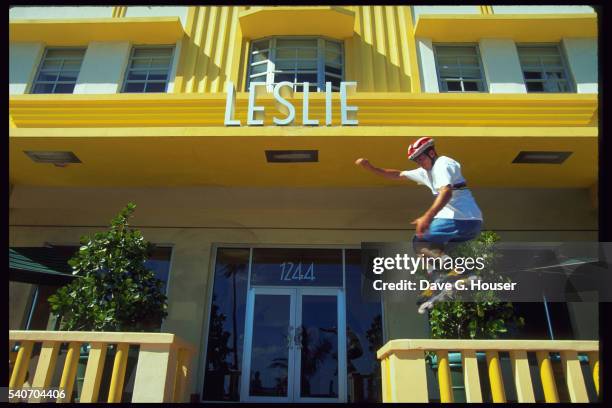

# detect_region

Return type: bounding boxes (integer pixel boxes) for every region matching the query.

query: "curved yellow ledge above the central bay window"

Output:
[238,6,355,39]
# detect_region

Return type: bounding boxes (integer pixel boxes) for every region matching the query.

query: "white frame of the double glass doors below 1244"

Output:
[240,286,347,403]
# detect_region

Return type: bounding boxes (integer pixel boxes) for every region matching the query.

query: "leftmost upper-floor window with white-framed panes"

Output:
[32,48,85,94]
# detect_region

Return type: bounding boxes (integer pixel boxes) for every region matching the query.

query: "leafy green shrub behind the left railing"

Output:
[49,203,167,331]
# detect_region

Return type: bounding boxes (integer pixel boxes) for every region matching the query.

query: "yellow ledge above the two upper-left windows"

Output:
[9,17,184,46]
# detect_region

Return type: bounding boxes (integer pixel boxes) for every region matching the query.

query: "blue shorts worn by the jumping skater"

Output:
[412,218,482,252]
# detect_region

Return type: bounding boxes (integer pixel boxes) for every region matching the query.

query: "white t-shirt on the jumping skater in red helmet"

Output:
[400,156,482,221]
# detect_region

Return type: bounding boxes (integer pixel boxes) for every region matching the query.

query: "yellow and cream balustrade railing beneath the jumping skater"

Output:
[377,339,599,402]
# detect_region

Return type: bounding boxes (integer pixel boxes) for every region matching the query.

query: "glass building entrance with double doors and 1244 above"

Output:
[202,247,383,403]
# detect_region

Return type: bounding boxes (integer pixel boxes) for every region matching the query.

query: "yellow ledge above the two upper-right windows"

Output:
[414,13,597,42]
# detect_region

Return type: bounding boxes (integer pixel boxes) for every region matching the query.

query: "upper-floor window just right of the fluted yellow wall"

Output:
[434,45,486,92]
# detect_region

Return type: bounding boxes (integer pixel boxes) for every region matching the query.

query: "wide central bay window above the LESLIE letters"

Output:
[249,37,344,92]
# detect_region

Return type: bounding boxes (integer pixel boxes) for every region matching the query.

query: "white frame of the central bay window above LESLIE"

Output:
[246,36,346,92]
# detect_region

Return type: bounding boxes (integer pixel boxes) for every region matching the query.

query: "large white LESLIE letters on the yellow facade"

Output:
[224,81,359,126]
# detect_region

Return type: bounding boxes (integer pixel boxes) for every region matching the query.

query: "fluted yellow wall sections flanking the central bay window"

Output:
[174,6,418,93]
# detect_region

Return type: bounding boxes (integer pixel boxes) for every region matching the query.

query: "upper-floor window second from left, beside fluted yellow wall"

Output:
[123,46,174,92]
